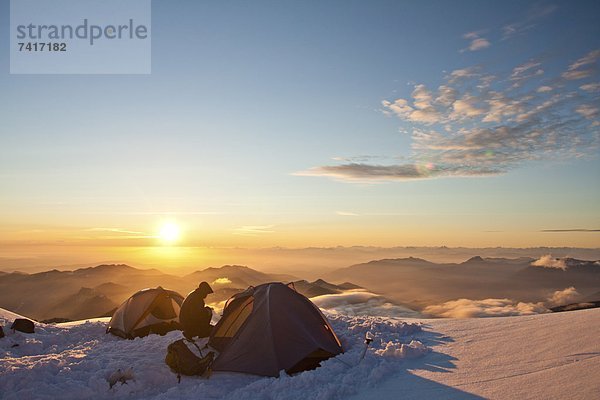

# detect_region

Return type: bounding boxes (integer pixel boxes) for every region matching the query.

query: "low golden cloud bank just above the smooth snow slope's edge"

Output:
[423,299,548,318]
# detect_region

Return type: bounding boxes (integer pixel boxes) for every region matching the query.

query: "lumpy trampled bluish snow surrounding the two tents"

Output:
[0,315,428,400]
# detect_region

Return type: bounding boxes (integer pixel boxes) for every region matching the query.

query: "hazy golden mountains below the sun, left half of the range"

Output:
[0,264,297,320]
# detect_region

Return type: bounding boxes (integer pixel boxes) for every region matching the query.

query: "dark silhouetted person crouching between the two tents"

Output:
[179,282,213,340]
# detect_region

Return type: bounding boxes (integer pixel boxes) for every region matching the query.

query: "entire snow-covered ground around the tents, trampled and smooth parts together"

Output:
[0,309,600,400]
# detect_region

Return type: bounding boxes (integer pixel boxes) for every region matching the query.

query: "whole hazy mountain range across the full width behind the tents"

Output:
[0,256,600,320]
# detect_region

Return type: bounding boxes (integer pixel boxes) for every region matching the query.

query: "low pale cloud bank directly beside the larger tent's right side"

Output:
[310,290,421,318]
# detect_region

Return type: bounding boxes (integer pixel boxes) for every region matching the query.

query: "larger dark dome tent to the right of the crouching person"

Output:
[209,283,343,377]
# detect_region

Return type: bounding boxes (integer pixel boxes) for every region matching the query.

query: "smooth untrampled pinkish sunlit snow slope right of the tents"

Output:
[356,309,600,400]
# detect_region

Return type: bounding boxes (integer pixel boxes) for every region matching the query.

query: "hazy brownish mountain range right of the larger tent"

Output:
[323,256,600,309]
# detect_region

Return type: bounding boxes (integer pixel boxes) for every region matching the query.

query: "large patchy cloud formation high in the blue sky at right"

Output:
[295,48,600,182]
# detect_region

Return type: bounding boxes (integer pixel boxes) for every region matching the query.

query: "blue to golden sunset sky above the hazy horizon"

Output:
[0,0,600,264]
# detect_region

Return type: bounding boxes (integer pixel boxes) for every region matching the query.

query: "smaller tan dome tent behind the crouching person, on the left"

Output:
[106,286,183,339]
